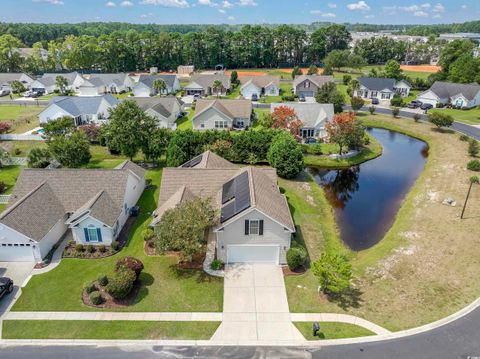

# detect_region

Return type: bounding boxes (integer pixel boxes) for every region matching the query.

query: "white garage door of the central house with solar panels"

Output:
[227,246,280,264]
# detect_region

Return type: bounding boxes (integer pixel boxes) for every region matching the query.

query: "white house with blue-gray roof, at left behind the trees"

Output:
[38,94,118,126]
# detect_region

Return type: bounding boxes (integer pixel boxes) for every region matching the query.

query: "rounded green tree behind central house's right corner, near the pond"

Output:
[267,132,304,178]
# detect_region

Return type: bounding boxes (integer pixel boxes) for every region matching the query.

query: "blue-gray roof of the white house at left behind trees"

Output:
[50,94,118,117]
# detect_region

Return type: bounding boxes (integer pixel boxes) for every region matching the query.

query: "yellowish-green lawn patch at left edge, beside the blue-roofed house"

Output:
[0,105,45,133]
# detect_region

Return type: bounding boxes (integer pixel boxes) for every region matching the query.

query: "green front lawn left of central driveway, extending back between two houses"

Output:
[12,170,223,312]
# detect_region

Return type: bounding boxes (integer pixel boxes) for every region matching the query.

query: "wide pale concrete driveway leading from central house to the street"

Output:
[212,264,304,342]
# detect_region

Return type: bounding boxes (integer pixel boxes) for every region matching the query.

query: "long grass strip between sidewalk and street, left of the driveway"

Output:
[2,320,220,340]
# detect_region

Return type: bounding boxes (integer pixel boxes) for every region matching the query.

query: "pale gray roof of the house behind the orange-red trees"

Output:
[270,102,334,128]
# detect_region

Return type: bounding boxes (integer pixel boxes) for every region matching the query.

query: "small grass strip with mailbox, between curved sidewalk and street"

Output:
[293,322,375,340]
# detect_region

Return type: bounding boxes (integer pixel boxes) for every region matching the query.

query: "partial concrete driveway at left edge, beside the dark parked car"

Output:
[0,262,35,318]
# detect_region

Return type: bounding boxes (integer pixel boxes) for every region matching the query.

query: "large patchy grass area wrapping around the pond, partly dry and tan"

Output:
[281,115,480,331]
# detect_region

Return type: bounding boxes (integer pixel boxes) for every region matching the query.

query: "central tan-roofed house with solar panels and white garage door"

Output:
[151,151,295,264]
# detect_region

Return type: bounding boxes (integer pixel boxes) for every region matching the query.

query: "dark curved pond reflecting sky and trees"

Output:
[308,128,428,251]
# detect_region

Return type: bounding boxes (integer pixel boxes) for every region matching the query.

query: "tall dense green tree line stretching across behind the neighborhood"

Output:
[0,25,351,73]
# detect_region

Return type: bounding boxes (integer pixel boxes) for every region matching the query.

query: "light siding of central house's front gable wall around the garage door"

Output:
[217,209,291,264]
